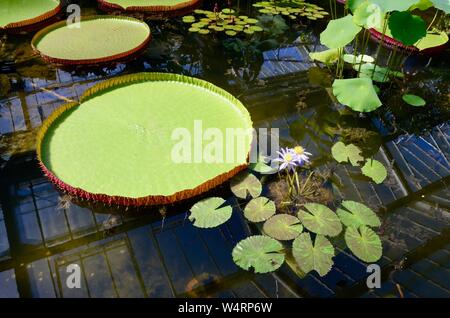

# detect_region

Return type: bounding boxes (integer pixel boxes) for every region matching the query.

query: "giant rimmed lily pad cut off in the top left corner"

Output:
[0,0,61,30]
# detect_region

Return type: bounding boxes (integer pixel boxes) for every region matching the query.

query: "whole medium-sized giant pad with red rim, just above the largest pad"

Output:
[32,16,151,65]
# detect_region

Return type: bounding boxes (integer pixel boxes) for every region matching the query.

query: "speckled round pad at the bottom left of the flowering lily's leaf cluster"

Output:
[232,235,284,274]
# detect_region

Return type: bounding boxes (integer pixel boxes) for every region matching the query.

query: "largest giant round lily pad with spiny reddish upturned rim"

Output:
[37,73,253,206]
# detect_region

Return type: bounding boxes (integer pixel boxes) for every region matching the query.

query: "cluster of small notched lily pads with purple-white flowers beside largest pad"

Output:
[189,144,385,276]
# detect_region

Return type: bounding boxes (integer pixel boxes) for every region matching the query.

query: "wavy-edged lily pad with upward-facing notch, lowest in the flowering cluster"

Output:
[292,233,334,276]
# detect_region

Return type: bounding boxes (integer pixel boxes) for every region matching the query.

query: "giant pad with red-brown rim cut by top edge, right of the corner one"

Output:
[97,0,201,16]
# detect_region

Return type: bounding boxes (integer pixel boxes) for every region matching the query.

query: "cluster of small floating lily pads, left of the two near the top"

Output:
[183,8,263,36]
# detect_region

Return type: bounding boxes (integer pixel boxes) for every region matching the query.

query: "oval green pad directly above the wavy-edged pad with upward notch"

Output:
[297,203,342,236]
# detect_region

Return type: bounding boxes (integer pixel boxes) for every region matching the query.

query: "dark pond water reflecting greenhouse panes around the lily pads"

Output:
[0,1,450,297]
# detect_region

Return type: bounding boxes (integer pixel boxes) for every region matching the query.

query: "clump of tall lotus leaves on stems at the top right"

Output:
[312,0,450,112]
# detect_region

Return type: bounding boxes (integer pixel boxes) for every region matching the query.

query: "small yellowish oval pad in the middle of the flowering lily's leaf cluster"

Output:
[263,214,303,241]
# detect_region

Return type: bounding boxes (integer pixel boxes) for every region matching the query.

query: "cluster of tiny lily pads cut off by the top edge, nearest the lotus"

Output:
[253,0,329,20]
